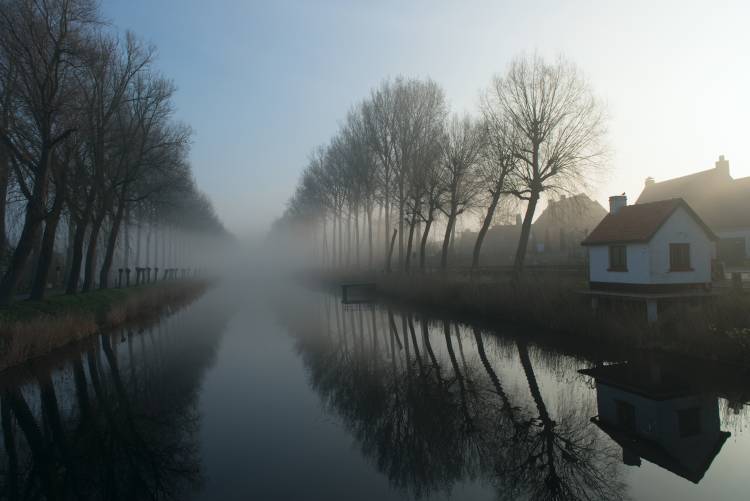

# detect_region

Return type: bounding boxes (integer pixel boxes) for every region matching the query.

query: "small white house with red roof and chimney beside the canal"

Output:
[582,195,717,293]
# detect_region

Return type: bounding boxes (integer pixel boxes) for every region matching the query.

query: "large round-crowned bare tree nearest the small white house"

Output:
[488,54,604,281]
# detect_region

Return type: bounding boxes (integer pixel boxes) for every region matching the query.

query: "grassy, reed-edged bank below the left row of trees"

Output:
[0,280,209,371]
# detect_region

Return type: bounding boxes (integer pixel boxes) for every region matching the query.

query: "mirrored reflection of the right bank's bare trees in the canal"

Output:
[290,298,625,500]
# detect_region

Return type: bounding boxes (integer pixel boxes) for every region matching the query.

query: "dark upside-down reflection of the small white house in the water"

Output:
[581,361,730,484]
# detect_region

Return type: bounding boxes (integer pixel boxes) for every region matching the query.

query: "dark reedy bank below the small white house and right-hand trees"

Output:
[305,272,750,367]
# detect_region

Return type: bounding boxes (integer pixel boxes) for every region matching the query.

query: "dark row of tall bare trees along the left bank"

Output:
[0,0,224,304]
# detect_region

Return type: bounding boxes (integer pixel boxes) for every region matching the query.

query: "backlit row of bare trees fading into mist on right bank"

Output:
[274,54,605,277]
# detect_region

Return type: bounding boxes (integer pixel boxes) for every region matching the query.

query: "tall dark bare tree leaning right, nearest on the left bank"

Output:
[0,0,97,304]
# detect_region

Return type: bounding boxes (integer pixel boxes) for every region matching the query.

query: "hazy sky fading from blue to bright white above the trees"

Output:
[103,0,750,234]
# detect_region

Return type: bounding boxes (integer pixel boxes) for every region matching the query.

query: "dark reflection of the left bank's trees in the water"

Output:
[0,296,225,500]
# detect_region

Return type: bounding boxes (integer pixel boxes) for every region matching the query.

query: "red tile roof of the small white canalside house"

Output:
[581,198,716,245]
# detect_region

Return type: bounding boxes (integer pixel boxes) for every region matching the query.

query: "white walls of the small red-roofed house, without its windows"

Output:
[589,207,715,284]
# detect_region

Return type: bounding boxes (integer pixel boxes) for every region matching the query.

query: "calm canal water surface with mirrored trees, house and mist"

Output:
[0,287,750,501]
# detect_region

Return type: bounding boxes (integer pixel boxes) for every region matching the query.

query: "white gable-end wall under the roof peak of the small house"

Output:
[649,207,715,284]
